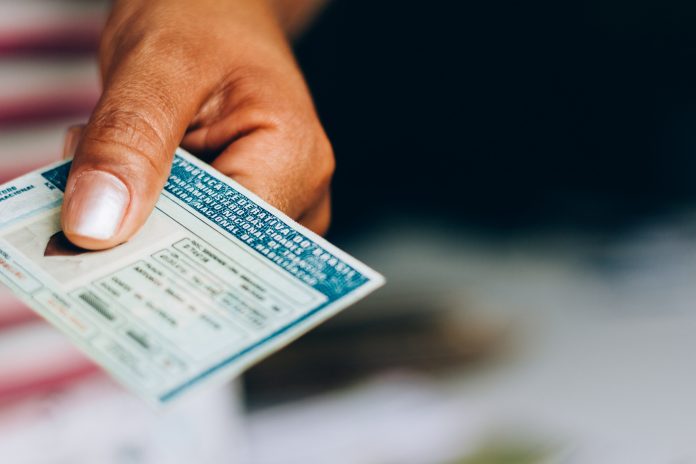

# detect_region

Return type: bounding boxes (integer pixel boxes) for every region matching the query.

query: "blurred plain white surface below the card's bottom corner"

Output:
[0,377,248,464]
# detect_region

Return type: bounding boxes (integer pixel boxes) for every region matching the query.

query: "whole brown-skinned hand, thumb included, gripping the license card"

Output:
[62,0,334,249]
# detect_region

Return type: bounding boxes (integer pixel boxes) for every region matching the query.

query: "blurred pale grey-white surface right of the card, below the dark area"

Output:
[251,218,696,464]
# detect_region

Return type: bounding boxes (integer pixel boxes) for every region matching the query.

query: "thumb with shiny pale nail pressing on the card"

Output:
[61,52,200,250]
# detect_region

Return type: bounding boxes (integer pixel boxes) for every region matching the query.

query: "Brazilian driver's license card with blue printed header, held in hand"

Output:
[0,150,384,405]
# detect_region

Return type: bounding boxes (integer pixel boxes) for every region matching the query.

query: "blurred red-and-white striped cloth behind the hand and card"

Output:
[0,0,106,401]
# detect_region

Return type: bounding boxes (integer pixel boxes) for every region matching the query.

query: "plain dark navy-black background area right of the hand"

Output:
[296,0,696,239]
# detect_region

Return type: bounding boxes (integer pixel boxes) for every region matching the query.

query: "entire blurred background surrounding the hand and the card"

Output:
[0,0,696,464]
